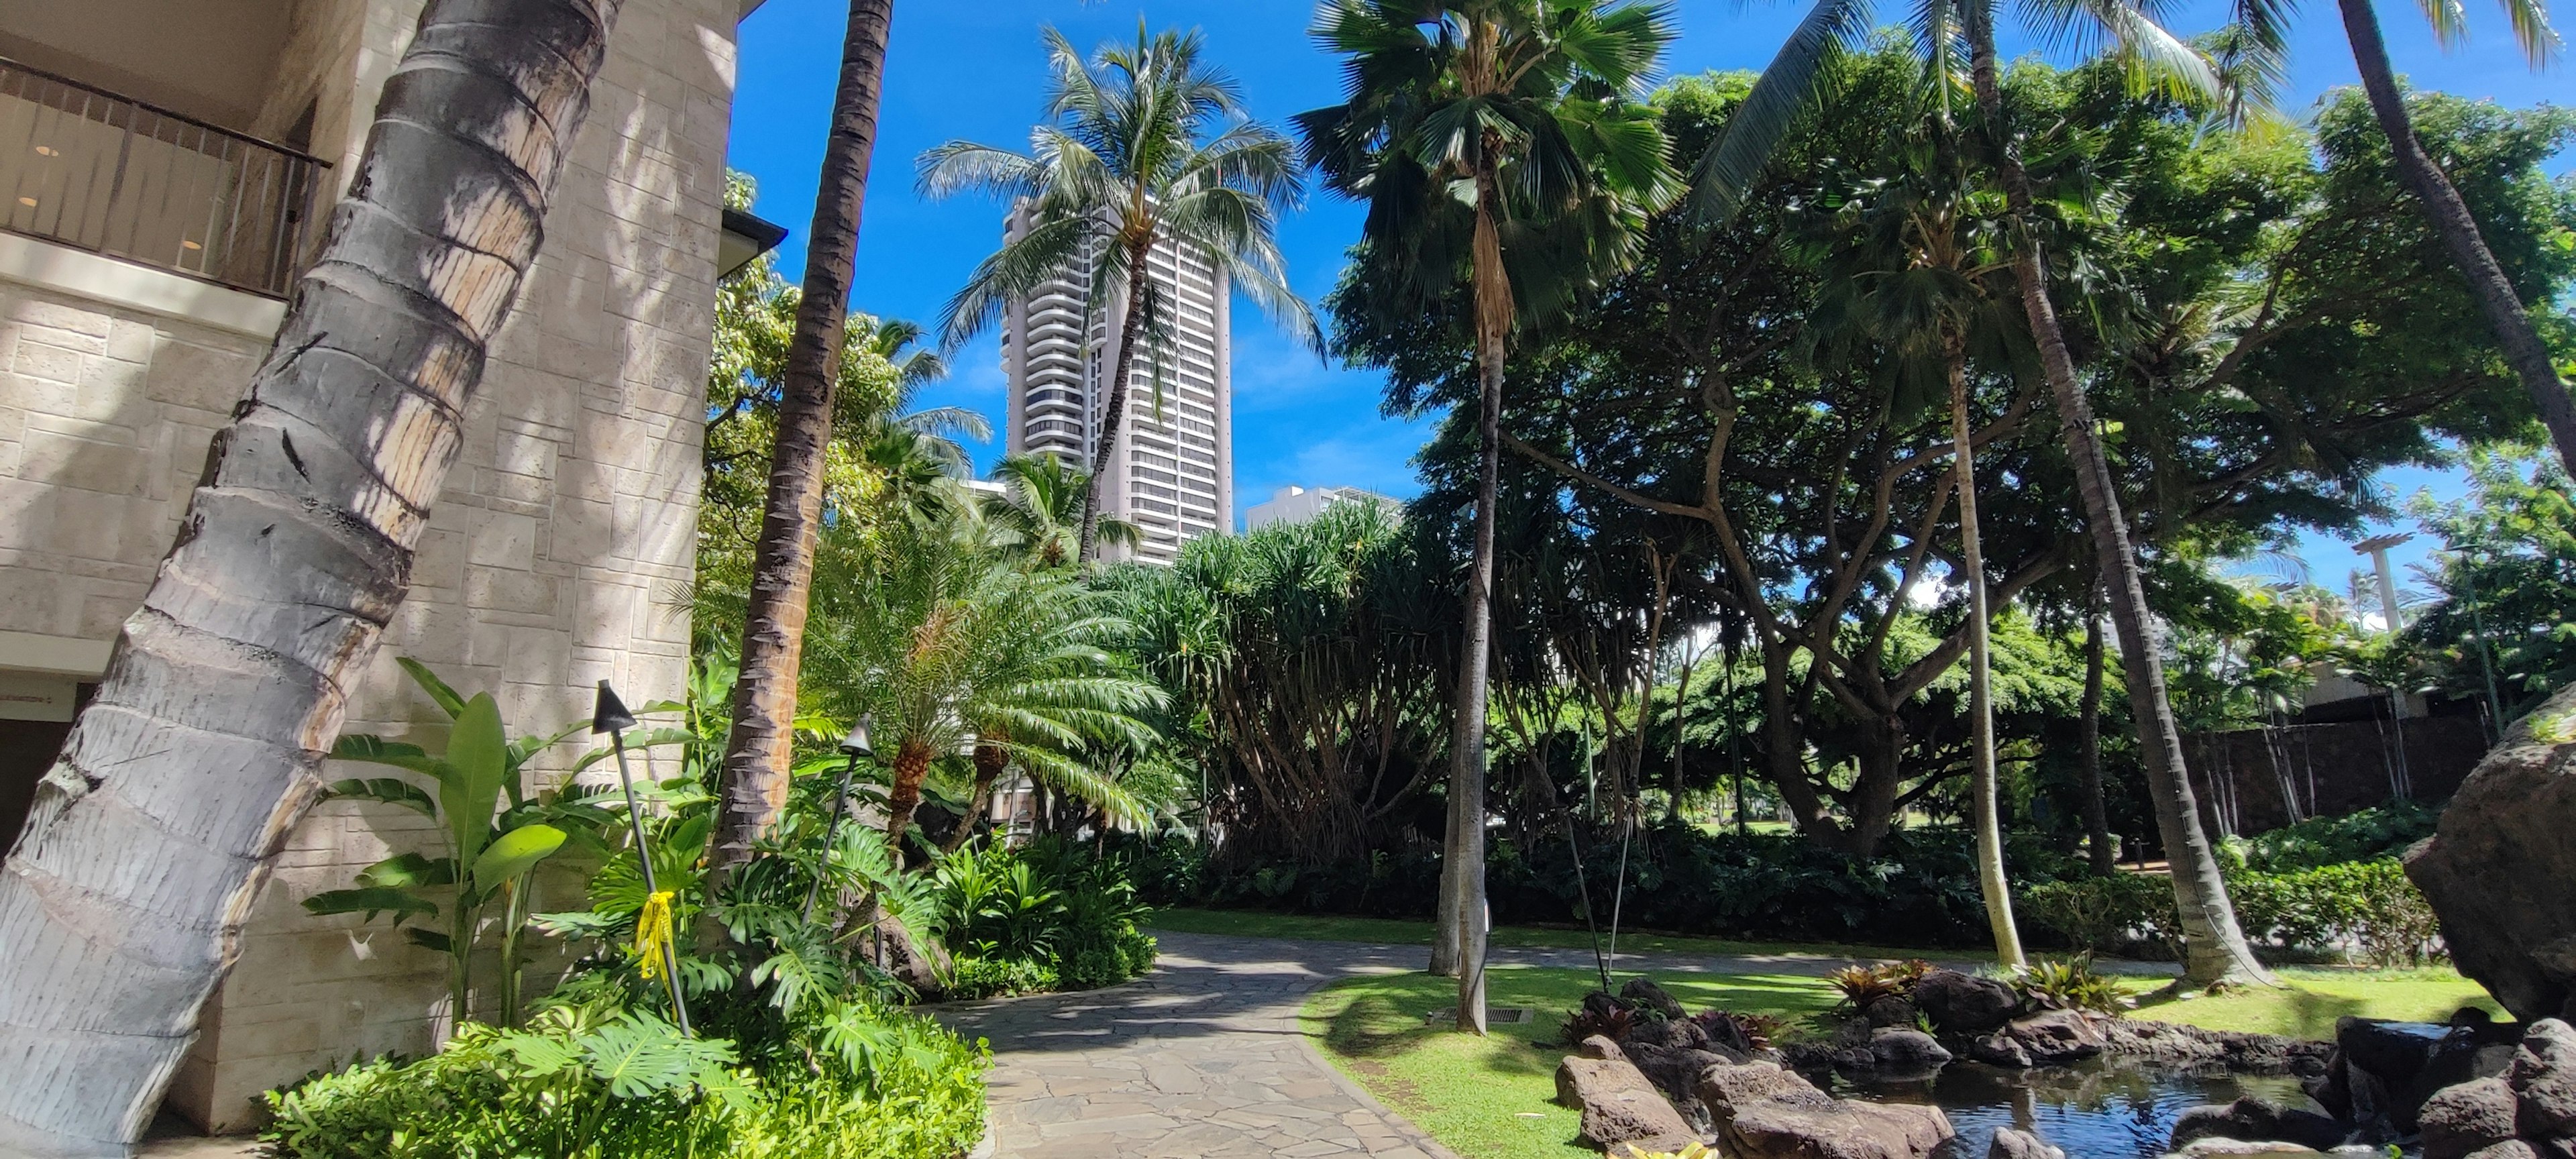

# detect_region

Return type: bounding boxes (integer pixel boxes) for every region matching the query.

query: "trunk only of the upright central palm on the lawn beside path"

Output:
[1448,140,1512,1036]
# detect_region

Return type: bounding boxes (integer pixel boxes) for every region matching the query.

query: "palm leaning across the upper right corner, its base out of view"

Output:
[2318,0,2576,472]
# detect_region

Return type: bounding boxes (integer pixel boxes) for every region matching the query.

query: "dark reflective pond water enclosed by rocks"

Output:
[1837,1058,2316,1159]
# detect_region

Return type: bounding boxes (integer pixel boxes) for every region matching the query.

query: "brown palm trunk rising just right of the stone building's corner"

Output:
[700,0,894,885]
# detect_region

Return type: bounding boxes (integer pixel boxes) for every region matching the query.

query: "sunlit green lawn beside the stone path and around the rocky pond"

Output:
[1308,963,2496,1159]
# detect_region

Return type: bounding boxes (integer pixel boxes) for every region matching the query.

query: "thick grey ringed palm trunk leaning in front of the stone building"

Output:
[0,0,619,1156]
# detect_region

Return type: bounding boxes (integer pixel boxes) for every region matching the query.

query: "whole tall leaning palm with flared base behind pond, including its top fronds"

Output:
[1695,0,2272,987]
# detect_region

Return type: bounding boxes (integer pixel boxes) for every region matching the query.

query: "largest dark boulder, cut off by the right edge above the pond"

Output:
[2406,685,2576,1022]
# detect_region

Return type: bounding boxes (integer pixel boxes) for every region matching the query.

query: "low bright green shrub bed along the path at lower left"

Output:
[260,1005,989,1159]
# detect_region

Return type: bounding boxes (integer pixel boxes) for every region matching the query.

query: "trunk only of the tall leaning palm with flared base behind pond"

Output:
[1966,0,2272,987]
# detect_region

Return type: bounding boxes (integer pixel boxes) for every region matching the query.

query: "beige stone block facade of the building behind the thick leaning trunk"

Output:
[0,0,745,1131]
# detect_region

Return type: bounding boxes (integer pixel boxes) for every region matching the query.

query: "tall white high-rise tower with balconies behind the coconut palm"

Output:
[1002,211,1234,564]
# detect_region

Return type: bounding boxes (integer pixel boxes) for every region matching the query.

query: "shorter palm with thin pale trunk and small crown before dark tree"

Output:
[1824,117,2027,969]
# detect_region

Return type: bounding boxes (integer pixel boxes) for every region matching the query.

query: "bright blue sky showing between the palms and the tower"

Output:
[729,0,2568,577]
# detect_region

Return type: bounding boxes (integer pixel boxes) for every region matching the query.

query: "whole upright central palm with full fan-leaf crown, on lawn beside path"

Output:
[1296,0,1680,1036]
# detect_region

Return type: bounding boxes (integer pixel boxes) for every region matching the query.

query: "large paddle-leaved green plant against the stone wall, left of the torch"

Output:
[304,659,588,1025]
